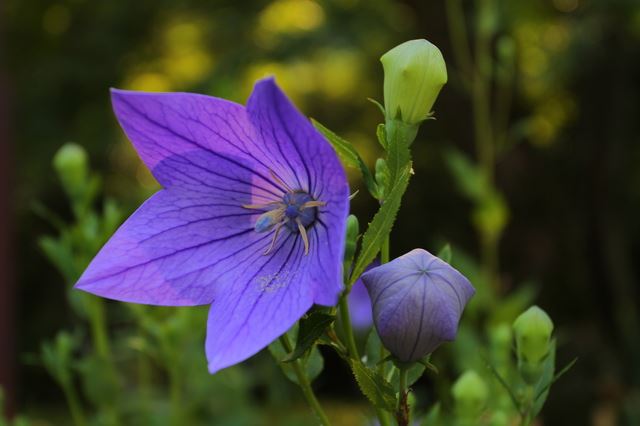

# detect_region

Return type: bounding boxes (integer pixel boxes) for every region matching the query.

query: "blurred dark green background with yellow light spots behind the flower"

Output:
[0,0,640,425]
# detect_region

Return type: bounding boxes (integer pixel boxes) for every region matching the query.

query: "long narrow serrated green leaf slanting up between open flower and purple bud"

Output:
[349,163,411,284]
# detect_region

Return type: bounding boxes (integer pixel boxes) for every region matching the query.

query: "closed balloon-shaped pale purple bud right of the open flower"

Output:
[362,249,475,362]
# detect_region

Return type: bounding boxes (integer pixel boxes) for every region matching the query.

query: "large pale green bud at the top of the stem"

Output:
[380,40,447,125]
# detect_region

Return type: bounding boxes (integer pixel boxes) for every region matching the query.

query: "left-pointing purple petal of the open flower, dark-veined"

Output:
[76,185,270,306]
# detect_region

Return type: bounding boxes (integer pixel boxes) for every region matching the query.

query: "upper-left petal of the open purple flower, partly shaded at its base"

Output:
[111,89,292,202]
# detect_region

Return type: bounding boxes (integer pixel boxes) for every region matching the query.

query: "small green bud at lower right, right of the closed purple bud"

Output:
[513,306,553,384]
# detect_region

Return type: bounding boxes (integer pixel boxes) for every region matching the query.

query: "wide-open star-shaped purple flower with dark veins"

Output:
[76,79,349,373]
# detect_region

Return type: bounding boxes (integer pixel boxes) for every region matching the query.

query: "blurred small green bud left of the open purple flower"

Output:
[53,143,89,197]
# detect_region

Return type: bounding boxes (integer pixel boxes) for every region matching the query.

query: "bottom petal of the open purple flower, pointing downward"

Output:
[206,234,313,373]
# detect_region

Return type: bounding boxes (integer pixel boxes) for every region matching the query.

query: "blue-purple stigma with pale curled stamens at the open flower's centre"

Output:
[243,187,325,254]
